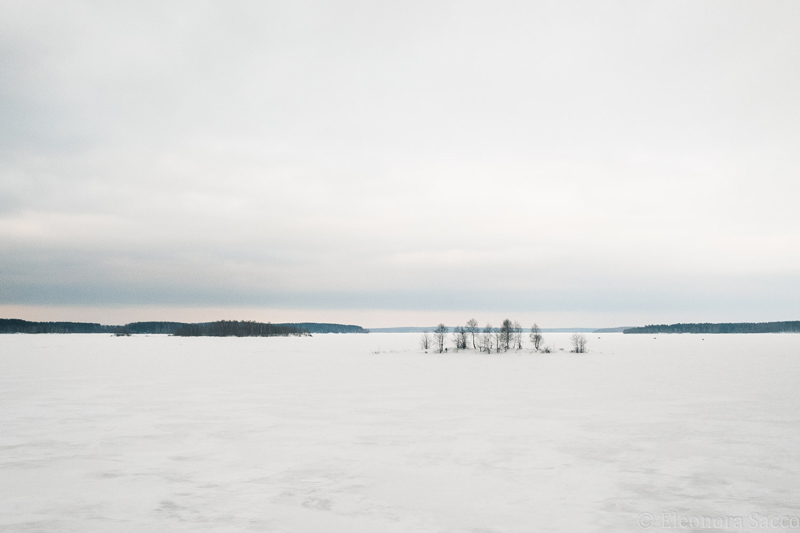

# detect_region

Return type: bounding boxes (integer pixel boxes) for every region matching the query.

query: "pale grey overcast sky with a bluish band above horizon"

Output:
[0,0,800,327]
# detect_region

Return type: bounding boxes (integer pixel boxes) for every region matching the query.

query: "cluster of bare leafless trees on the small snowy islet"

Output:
[420,318,587,353]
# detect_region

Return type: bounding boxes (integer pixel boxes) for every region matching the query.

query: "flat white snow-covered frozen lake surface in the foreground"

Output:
[0,334,800,533]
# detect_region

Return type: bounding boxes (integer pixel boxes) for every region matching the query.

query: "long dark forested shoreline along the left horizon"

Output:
[0,318,369,336]
